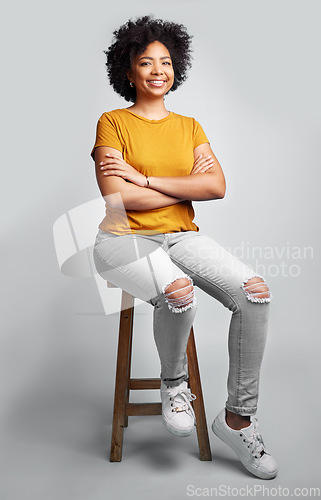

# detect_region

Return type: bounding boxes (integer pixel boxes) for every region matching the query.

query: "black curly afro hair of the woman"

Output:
[104,15,192,102]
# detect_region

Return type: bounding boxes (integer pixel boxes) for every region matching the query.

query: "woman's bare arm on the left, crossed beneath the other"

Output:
[95,146,182,210]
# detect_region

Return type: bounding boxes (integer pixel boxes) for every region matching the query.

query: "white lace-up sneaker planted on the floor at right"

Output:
[212,409,278,479]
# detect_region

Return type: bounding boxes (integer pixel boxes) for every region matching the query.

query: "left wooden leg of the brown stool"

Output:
[110,291,134,462]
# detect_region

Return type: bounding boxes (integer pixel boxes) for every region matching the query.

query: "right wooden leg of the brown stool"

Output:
[187,327,212,460]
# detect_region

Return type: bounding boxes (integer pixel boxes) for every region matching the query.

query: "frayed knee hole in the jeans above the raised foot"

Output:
[163,277,195,312]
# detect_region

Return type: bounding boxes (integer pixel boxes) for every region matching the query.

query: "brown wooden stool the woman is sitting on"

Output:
[107,282,212,462]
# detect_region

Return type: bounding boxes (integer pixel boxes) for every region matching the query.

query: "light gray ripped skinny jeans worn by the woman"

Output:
[94,230,271,415]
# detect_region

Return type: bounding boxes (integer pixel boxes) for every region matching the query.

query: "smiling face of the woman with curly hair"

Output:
[127,41,174,99]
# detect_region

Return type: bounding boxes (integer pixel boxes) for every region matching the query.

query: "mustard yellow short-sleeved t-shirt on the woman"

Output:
[91,108,209,234]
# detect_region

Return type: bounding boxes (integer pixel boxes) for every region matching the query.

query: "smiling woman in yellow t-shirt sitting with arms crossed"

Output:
[92,16,277,479]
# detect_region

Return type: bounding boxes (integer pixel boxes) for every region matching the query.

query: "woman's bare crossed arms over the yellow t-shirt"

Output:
[95,143,225,210]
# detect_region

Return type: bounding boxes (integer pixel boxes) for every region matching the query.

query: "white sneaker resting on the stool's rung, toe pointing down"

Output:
[161,381,196,437]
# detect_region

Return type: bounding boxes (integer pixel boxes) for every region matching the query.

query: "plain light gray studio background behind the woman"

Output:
[0,0,321,500]
